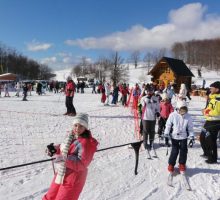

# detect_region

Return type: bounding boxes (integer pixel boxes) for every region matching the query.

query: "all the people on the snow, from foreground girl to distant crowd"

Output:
[0,76,220,200]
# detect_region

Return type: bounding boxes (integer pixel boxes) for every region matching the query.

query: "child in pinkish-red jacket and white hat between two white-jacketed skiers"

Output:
[157,93,174,143]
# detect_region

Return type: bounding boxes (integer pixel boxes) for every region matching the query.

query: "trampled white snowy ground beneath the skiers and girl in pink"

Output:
[0,88,220,200]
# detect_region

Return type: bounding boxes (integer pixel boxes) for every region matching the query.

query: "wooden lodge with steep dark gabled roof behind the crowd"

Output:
[148,57,194,90]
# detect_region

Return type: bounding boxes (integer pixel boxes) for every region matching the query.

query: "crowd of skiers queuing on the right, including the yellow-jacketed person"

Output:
[92,81,220,169]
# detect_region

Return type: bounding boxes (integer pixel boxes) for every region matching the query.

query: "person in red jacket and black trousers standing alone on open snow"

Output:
[64,76,76,116]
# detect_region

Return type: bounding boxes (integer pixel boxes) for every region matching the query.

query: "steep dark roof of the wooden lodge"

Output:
[149,57,194,77]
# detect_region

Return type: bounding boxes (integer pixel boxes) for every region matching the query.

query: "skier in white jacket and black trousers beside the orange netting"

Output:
[141,89,160,150]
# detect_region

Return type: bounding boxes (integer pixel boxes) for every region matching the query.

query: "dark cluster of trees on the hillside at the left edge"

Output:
[0,43,55,80]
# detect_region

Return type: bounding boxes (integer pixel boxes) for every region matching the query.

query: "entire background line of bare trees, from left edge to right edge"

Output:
[0,38,220,84]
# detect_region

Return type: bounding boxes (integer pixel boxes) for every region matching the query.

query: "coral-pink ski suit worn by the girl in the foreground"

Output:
[43,130,98,200]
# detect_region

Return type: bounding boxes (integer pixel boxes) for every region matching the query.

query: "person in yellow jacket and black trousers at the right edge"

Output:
[203,81,220,164]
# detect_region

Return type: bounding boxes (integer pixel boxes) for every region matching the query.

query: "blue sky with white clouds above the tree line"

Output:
[0,0,220,69]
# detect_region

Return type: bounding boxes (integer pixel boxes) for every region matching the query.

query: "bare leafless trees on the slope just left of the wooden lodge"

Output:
[72,48,166,85]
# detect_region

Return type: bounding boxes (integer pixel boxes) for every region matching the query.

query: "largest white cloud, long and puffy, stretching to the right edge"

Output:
[65,3,220,51]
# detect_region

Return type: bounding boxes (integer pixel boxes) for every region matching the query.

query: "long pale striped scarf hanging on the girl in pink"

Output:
[55,133,74,184]
